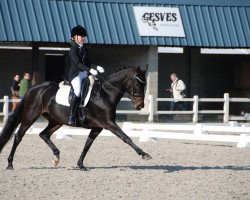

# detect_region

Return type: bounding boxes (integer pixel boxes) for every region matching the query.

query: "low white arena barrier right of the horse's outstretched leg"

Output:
[122,122,250,148]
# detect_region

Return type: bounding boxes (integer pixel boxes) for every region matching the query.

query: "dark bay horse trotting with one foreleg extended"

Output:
[0,67,151,171]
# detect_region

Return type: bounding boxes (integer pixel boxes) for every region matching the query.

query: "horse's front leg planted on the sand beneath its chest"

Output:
[77,128,102,171]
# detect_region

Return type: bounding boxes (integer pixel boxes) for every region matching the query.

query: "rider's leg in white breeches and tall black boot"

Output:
[68,72,87,125]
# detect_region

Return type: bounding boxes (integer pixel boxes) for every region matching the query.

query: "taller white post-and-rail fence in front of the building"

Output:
[0,93,250,123]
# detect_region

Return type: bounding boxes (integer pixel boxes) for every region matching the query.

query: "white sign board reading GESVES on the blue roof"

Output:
[133,6,185,37]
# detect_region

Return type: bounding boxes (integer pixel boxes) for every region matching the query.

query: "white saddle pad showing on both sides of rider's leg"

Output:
[56,75,95,107]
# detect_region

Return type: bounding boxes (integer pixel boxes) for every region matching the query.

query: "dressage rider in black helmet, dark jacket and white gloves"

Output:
[68,25,104,125]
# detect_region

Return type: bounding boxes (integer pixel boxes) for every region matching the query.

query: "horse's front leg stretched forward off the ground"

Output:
[105,122,152,160]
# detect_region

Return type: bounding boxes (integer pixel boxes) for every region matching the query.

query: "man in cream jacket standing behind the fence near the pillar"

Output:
[166,73,186,111]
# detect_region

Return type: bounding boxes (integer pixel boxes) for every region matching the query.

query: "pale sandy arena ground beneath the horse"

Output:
[0,135,250,200]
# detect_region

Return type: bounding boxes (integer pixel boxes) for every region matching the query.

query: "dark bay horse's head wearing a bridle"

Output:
[126,66,148,110]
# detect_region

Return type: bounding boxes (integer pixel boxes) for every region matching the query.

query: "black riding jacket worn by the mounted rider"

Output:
[68,42,91,82]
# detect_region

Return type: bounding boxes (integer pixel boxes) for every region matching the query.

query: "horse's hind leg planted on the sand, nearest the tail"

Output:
[7,116,39,169]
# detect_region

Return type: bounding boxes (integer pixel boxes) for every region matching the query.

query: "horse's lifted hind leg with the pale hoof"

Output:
[39,121,62,166]
